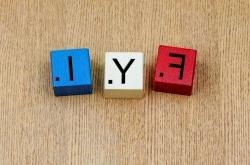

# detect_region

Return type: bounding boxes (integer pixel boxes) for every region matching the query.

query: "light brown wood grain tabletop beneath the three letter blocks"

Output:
[0,0,250,165]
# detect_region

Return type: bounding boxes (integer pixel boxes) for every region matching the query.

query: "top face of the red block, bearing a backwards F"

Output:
[154,46,197,86]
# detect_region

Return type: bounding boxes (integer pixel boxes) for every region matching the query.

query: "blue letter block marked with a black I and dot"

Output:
[50,49,92,96]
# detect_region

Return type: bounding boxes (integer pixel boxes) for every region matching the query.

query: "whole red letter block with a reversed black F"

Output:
[154,46,197,96]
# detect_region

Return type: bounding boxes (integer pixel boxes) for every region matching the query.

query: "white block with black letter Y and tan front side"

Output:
[104,52,144,98]
